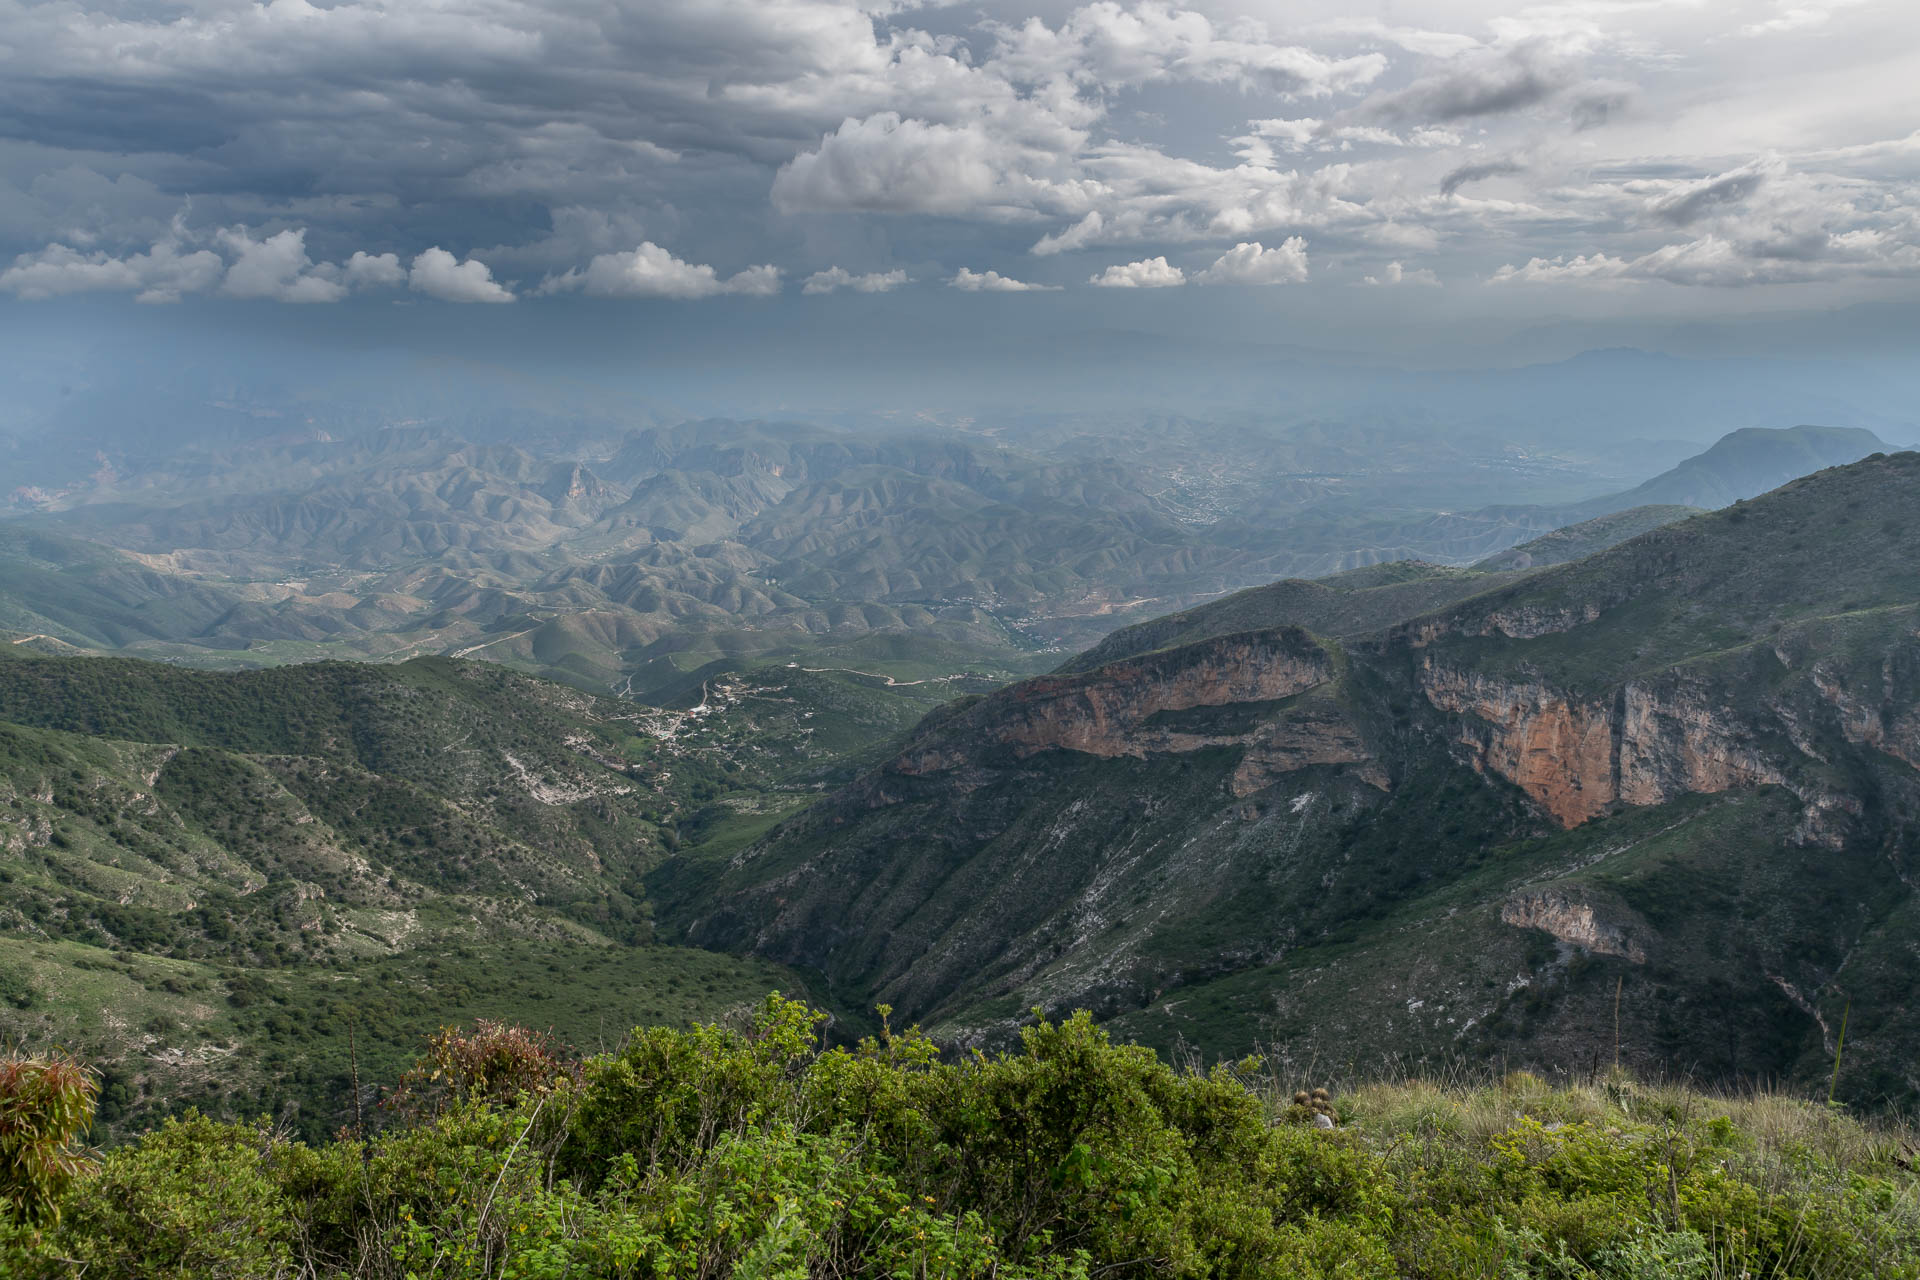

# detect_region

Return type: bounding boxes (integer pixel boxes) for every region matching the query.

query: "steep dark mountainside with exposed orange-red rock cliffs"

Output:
[683,455,1920,1096]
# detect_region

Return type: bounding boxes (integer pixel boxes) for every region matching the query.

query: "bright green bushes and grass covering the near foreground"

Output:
[0,996,1920,1280]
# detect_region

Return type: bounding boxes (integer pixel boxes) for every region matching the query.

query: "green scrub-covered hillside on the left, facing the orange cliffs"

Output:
[0,656,793,1132]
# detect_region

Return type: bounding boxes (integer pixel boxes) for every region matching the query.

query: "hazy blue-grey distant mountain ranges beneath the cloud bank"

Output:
[0,416,1878,710]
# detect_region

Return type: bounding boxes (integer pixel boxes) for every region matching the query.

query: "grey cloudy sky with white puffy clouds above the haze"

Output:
[0,0,1920,360]
